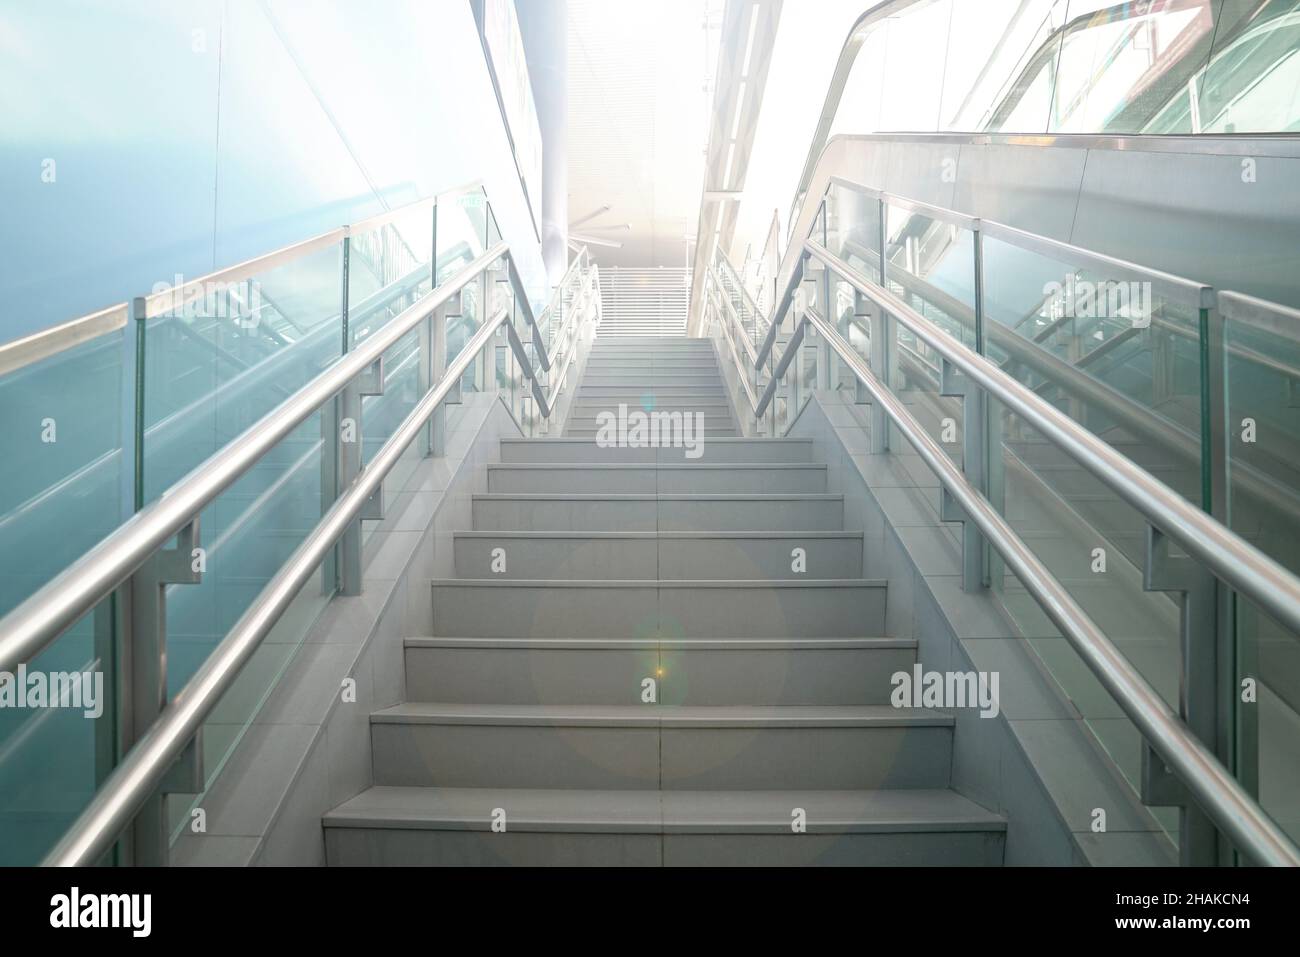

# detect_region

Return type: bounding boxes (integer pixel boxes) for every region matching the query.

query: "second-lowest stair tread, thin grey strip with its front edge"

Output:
[371,701,953,728]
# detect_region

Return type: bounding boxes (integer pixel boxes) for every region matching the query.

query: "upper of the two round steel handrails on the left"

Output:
[0,242,508,671]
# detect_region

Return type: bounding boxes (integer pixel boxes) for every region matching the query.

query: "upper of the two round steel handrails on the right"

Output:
[803,239,1300,632]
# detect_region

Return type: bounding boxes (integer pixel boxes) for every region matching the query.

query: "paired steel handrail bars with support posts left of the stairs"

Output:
[0,231,599,865]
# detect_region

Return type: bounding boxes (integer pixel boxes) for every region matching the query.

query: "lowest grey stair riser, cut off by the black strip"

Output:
[325,827,1005,867]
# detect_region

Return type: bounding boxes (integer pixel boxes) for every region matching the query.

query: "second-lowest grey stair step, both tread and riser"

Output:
[371,702,953,791]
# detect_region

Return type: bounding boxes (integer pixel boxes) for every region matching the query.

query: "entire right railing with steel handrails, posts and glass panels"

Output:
[706,171,1300,865]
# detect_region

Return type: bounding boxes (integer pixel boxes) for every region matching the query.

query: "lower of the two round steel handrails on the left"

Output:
[43,304,508,867]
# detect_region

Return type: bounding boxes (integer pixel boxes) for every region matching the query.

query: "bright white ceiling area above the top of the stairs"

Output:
[568,0,723,267]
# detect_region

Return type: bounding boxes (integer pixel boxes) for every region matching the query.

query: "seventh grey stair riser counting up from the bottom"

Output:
[488,465,827,494]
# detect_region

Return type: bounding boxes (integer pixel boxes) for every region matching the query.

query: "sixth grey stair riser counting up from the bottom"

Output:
[473,498,844,532]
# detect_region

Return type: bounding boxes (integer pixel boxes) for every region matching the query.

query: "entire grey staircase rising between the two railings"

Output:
[324,339,1005,865]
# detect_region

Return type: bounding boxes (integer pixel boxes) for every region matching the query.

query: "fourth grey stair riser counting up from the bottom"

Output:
[433,584,885,638]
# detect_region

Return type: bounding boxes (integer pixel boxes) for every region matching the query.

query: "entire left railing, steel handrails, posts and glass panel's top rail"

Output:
[0,187,599,863]
